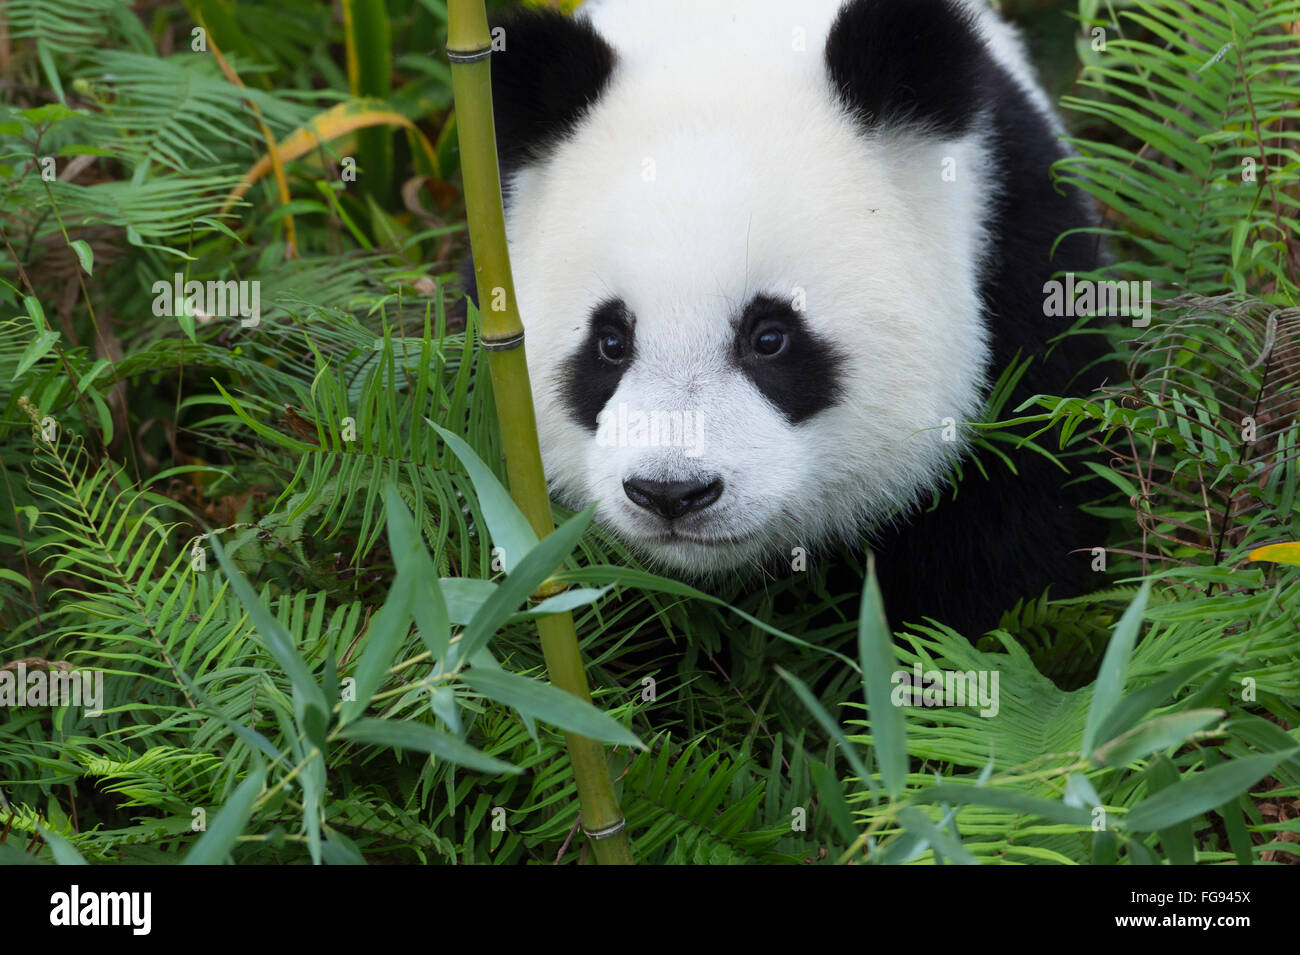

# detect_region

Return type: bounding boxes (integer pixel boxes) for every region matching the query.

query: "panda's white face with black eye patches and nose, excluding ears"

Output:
[488,0,992,576]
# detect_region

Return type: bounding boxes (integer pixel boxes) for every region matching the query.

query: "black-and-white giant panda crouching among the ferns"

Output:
[469,0,1102,634]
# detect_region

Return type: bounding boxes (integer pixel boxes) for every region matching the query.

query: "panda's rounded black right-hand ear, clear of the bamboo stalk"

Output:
[826,0,992,135]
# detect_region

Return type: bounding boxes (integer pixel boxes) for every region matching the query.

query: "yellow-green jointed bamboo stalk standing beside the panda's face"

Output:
[447,0,632,865]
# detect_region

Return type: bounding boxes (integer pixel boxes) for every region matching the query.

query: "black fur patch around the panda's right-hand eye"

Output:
[732,295,842,425]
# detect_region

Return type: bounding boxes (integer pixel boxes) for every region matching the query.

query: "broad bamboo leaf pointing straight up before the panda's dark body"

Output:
[858,557,907,799]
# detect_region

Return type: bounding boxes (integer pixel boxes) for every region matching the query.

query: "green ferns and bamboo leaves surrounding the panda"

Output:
[0,0,1300,864]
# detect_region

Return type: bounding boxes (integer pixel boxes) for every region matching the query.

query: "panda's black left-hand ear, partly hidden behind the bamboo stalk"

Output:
[491,10,615,170]
